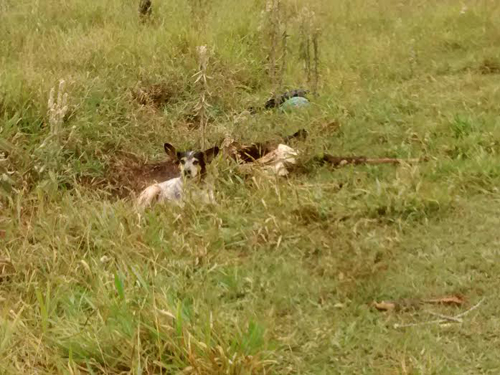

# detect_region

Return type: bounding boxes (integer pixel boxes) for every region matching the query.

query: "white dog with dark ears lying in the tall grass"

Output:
[137,143,219,209]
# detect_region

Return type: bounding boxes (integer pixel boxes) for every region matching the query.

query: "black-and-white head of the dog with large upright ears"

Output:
[163,143,219,178]
